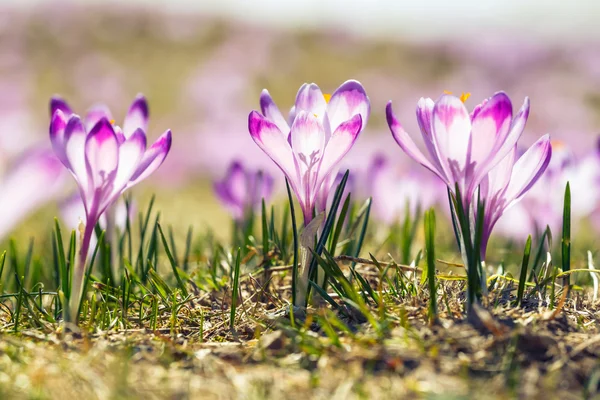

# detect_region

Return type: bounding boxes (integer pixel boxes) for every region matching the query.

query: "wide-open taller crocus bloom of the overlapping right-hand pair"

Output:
[386,92,529,209]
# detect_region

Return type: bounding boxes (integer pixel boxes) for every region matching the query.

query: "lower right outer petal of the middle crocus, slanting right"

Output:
[317,114,362,187]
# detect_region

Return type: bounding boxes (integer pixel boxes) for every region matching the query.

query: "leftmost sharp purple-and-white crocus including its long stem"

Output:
[50,95,171,321]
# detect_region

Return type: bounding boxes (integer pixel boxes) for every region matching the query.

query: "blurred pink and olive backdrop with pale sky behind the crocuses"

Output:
[0,0,600,253]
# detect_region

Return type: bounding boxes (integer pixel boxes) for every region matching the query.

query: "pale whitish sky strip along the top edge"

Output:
[0,0,600,41]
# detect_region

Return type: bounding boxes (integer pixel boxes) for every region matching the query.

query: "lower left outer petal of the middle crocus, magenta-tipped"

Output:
[248,111,300,188]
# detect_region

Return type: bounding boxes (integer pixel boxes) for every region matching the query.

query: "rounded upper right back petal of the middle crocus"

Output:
[327,80,371,132]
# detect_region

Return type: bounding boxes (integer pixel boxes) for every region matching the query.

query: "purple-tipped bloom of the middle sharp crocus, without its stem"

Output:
[248,80,370,225]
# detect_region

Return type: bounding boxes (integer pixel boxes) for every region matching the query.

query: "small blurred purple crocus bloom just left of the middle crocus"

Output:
[213,161,273,223]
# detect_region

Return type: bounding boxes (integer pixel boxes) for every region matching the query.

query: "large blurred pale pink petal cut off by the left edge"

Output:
[0,149,65,238]
